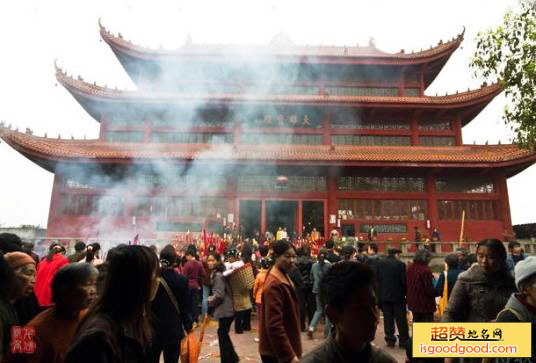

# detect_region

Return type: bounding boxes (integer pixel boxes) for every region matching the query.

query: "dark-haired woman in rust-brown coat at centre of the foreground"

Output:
[259,241,302,363]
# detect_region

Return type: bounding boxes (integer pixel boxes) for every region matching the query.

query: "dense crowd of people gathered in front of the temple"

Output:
[0,234,536,363]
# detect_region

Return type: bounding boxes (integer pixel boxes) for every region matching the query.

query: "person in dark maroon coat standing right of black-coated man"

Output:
[407,249,436,322]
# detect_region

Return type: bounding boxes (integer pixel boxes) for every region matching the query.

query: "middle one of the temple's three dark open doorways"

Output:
[266,200,298,238]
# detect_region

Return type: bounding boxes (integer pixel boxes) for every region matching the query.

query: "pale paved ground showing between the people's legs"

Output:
[182,318,406,363]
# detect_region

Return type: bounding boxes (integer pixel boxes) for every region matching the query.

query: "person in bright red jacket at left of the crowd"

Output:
[34,242,69,306]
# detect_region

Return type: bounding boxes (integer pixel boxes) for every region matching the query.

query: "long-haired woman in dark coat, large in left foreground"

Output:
[65,245,160,363]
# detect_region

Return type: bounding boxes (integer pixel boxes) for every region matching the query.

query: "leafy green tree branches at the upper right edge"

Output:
[471,0,536,150]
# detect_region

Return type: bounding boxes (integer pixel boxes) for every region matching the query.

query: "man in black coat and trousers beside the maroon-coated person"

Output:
[378,248,409,347]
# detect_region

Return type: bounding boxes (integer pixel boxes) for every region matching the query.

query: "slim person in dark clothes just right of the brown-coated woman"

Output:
[296,246,316,332]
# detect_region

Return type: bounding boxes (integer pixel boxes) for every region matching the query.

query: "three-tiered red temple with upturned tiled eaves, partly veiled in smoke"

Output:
[0,25,536,245]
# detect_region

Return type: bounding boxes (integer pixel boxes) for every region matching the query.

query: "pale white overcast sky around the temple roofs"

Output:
[0,0,536,226]
